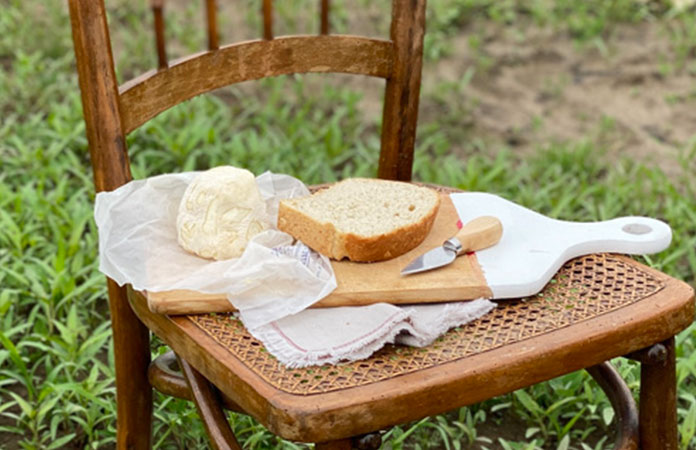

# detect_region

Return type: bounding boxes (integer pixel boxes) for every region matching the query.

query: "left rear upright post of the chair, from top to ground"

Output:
[68,0,152,449]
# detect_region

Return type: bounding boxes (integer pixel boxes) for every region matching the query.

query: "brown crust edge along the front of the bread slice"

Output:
[278,182,440,262]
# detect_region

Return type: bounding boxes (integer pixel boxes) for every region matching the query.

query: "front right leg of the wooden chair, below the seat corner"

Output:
[640,338,679,450]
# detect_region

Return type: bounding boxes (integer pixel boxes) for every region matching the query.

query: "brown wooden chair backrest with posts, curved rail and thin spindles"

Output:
[69,0,426,191]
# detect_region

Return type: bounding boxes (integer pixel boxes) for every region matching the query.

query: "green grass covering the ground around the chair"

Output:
[0,0,696,449]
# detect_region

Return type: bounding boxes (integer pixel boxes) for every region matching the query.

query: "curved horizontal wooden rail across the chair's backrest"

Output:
[119,35,393,133]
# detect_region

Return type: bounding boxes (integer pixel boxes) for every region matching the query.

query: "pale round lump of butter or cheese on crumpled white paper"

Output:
[176,166,270,260]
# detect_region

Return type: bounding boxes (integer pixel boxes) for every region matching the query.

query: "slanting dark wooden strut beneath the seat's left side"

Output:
[177,357,241,450]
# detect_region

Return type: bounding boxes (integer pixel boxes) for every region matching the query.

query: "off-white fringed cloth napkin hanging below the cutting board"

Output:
[250,299,495,368]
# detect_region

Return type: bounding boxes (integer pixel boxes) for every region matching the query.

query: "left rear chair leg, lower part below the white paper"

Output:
[107,279,152,450]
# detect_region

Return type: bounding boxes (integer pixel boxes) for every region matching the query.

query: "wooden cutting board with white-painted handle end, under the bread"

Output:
[148,192,672,314]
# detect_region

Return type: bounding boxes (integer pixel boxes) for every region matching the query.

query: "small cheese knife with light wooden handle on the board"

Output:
[401,216,503,275]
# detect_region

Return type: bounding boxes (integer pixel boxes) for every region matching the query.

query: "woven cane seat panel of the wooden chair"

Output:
[188,254,664,395]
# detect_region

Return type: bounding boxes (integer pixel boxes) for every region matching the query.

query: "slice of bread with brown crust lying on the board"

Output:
[278,178,440,262]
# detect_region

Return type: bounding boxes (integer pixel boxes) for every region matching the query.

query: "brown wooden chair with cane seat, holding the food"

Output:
[69,0,694,449]
